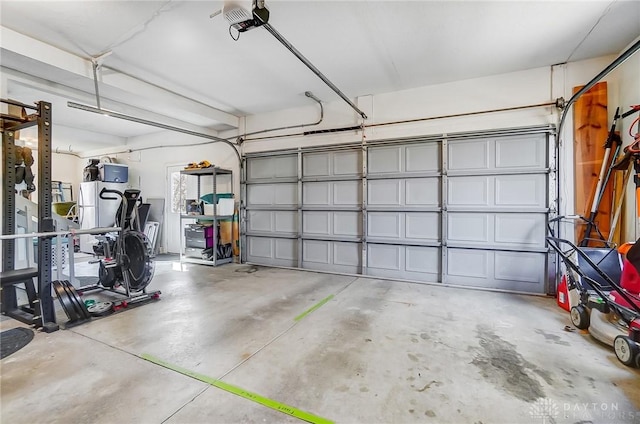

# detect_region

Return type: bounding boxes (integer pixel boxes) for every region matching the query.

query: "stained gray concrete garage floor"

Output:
[0,262,640,424]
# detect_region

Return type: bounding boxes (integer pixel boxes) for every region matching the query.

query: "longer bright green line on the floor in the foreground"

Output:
[140,352,333,424]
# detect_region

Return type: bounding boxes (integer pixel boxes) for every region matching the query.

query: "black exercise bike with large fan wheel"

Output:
[82,188,161,309]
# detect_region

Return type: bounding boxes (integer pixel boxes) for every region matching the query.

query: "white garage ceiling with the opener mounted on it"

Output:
[0,0,640,152]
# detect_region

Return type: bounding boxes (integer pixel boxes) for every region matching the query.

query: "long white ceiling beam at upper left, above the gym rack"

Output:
[0,26,239,128]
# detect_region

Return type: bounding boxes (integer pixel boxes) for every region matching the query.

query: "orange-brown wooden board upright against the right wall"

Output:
[573,82,613,245]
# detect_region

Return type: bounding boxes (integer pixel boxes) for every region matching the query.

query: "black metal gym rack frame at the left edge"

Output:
[0,99,59,332]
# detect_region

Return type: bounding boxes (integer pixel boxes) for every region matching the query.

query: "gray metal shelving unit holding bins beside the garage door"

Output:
[180,166,233,266]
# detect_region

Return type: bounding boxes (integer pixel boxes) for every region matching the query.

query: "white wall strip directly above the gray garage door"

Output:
[234,56,617,157]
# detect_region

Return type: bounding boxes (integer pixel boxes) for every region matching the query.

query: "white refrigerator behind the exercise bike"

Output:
[78,181,127,253]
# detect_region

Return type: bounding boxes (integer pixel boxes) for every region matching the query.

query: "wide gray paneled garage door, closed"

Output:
[242,127,555,293]
